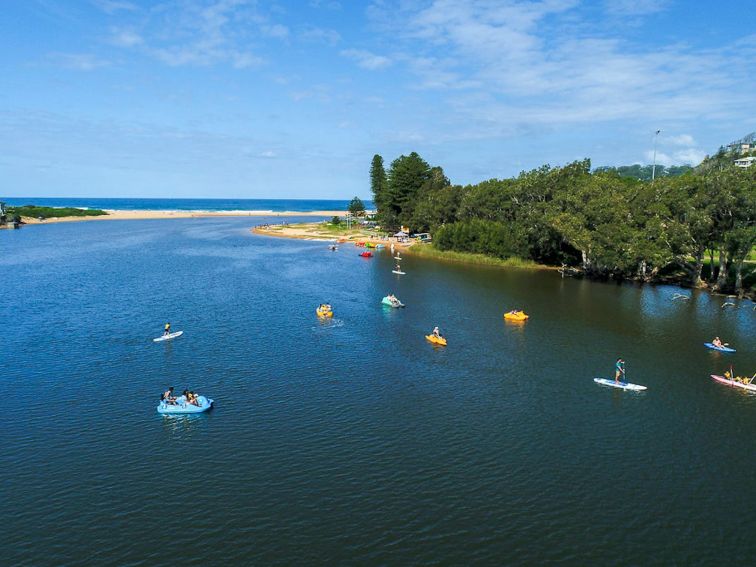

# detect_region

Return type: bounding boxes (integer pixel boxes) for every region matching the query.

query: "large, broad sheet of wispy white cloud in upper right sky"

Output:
[368,0,753,138]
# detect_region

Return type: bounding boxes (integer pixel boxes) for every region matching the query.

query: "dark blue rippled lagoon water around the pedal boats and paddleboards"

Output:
[0,218,756,566]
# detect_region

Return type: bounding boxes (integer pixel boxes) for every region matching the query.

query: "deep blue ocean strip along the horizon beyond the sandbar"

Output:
[0,196,374,213]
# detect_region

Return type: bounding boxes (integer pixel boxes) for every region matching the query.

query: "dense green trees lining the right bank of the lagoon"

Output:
[371,153,756,293]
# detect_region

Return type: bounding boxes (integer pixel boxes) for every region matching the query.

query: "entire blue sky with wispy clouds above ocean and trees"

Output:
[0,0,756,198]
